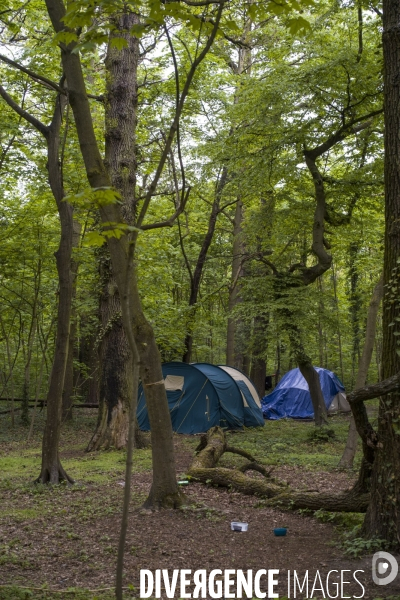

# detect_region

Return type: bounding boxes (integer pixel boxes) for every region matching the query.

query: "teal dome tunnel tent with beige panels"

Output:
[137,362,264,433]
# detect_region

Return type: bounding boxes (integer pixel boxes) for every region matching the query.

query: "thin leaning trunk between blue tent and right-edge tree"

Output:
[338,278,383,469]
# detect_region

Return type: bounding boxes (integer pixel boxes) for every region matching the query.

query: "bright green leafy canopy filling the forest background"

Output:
[0,0,383,434]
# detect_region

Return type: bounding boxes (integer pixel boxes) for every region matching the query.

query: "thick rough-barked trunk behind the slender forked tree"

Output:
[88,13,139,451]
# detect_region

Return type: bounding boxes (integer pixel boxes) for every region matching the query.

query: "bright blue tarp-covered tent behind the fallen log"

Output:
[262,367,350,420]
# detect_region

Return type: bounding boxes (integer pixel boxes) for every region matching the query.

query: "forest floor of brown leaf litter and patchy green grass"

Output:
[0,409,400,600]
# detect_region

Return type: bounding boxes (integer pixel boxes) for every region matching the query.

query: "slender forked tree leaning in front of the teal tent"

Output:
[46,0,228,507]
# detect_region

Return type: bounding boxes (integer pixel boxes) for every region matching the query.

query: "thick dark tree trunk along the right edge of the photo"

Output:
[363,0,400,548]
